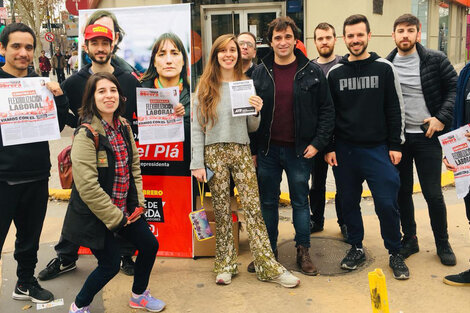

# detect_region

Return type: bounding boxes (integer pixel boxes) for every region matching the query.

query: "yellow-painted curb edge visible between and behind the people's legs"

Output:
[49,171,454,205]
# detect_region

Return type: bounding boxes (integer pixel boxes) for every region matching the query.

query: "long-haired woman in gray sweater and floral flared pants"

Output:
[190,34,300,288]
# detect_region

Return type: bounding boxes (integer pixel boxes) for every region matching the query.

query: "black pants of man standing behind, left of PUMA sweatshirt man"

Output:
[308,153,344,227]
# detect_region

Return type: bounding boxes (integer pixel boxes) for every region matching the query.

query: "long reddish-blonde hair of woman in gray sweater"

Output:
[196,34,245,132]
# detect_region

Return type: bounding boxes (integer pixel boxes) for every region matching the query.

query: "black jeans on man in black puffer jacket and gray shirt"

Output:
[397,133,449,244]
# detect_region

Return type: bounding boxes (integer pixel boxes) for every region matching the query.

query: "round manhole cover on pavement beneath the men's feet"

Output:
[277,236,374,276]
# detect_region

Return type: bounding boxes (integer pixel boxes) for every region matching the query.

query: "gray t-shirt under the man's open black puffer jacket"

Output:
[393,52,431,133]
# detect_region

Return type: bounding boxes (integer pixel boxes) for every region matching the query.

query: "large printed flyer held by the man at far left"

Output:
[0,77,60,146]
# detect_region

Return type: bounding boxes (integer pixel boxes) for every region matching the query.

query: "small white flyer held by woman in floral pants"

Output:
[229,79,256,116]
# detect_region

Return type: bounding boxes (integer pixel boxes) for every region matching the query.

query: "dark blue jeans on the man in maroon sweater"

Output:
[257,144,312,251]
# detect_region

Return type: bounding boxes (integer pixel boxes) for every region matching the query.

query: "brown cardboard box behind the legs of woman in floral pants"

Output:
[193,197,240,257]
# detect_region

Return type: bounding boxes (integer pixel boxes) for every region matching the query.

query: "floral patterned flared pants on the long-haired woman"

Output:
[204,143,286,280]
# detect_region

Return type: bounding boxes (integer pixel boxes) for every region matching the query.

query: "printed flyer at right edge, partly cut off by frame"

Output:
[438,124,470,199]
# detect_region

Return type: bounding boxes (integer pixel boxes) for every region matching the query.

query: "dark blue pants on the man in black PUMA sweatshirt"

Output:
[334,142,401,253]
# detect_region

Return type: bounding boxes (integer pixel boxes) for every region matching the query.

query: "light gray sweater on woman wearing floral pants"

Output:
[190,82,261,170]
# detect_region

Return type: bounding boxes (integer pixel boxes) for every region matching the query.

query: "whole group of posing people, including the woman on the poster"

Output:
[0,7,470,313]
